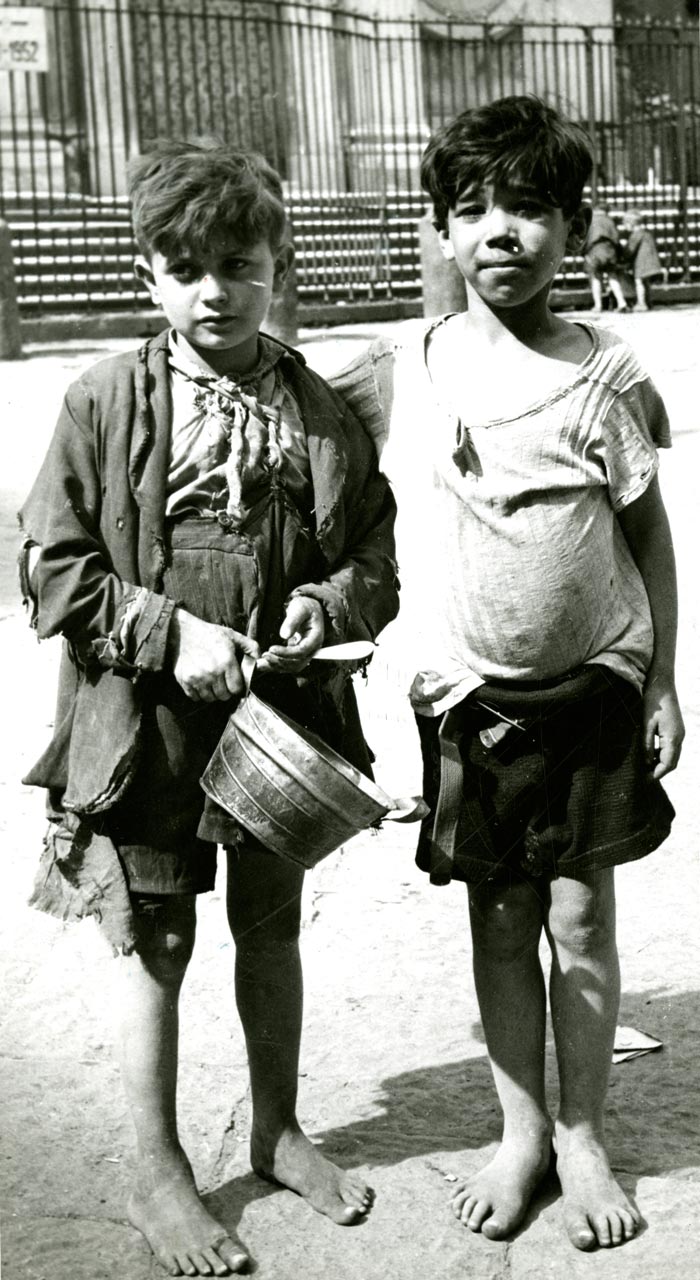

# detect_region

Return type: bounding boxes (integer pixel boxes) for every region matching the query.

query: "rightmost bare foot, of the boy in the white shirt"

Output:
[557,1125,641,1249]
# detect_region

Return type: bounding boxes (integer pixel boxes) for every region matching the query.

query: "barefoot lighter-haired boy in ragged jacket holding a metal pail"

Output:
[22,143,398,1276]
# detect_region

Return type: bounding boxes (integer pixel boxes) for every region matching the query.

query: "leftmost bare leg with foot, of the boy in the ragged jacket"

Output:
[118,897,250,1276]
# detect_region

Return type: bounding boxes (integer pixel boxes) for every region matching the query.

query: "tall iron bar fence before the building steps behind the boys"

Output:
[0,0,700,311]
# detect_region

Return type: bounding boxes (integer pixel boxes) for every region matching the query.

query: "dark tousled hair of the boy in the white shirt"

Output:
[421,95,593,230]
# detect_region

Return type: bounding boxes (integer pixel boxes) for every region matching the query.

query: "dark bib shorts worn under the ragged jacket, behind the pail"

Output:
[102,512,371,893]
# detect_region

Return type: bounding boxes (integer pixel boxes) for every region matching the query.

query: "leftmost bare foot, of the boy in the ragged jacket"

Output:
[128,1156,250,1276]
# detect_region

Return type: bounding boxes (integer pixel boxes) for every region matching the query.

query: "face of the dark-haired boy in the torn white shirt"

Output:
[440,183,587,310]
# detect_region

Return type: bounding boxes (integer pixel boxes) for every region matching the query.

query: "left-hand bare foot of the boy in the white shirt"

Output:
[452,1133,552,1240]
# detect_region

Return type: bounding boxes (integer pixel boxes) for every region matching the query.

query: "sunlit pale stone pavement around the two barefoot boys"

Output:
[0,308,700,1280]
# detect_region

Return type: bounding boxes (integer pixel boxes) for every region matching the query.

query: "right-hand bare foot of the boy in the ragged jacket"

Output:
[251,1129,375,1226]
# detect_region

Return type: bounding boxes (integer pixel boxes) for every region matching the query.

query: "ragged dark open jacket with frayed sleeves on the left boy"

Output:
[20,333,398,936]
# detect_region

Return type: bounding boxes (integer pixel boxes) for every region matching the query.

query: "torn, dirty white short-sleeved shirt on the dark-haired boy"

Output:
[338,316,671,714]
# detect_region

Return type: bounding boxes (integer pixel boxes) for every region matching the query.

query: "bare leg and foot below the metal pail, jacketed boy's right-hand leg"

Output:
[228,850,374,1225]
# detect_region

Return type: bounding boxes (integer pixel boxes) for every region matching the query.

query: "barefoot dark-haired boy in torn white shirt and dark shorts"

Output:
[337,97,683,1249]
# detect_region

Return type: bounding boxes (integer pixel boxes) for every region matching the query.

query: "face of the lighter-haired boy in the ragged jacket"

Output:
[136,234,292,374]
